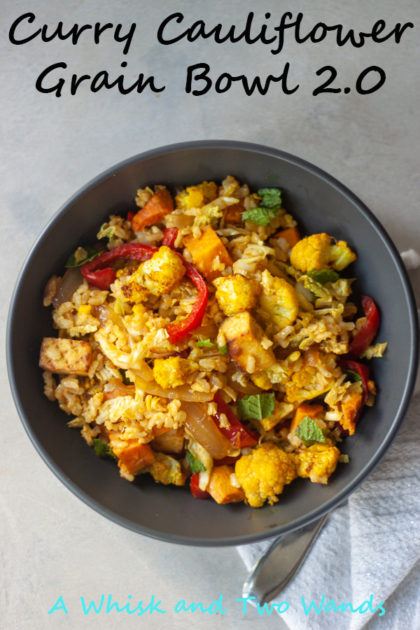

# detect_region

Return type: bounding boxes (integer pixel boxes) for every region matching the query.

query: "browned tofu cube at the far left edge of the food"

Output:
[39,337,92,376]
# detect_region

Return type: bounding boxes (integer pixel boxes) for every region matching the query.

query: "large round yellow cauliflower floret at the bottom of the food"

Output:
[235,442,297,507]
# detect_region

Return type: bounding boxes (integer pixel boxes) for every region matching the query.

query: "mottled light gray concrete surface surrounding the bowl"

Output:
[0,0,420,630]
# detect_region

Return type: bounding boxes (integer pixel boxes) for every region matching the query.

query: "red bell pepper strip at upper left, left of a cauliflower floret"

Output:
[80,243,158,290]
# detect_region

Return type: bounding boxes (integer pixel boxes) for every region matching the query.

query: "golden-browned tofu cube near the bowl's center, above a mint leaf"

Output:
[220,311,276,374]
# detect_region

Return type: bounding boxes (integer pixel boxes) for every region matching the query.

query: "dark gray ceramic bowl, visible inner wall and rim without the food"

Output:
[8,141,417,545]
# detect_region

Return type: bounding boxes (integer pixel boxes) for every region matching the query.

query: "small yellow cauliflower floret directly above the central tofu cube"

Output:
[213,274,260,315]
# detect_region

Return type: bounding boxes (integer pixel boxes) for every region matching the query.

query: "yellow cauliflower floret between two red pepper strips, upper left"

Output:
[138,245,185,295]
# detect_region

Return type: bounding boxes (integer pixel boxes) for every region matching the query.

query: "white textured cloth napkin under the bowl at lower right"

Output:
[237,249,420,630]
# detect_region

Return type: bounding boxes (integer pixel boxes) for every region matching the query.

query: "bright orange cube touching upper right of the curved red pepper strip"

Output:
[184,225,233,280]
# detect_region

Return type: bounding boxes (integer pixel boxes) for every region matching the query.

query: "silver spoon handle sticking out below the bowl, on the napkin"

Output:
[242,515,328,604]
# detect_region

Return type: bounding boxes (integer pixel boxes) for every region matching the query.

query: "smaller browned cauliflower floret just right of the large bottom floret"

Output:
[295,444,340,484]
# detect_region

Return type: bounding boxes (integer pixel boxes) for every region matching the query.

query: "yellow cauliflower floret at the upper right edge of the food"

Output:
[290,232,356,272]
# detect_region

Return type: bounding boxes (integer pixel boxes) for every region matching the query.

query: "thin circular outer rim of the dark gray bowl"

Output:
[6,139,419,547]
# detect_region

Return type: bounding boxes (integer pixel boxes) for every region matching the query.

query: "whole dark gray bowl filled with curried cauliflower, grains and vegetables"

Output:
[8,141,418,545]
